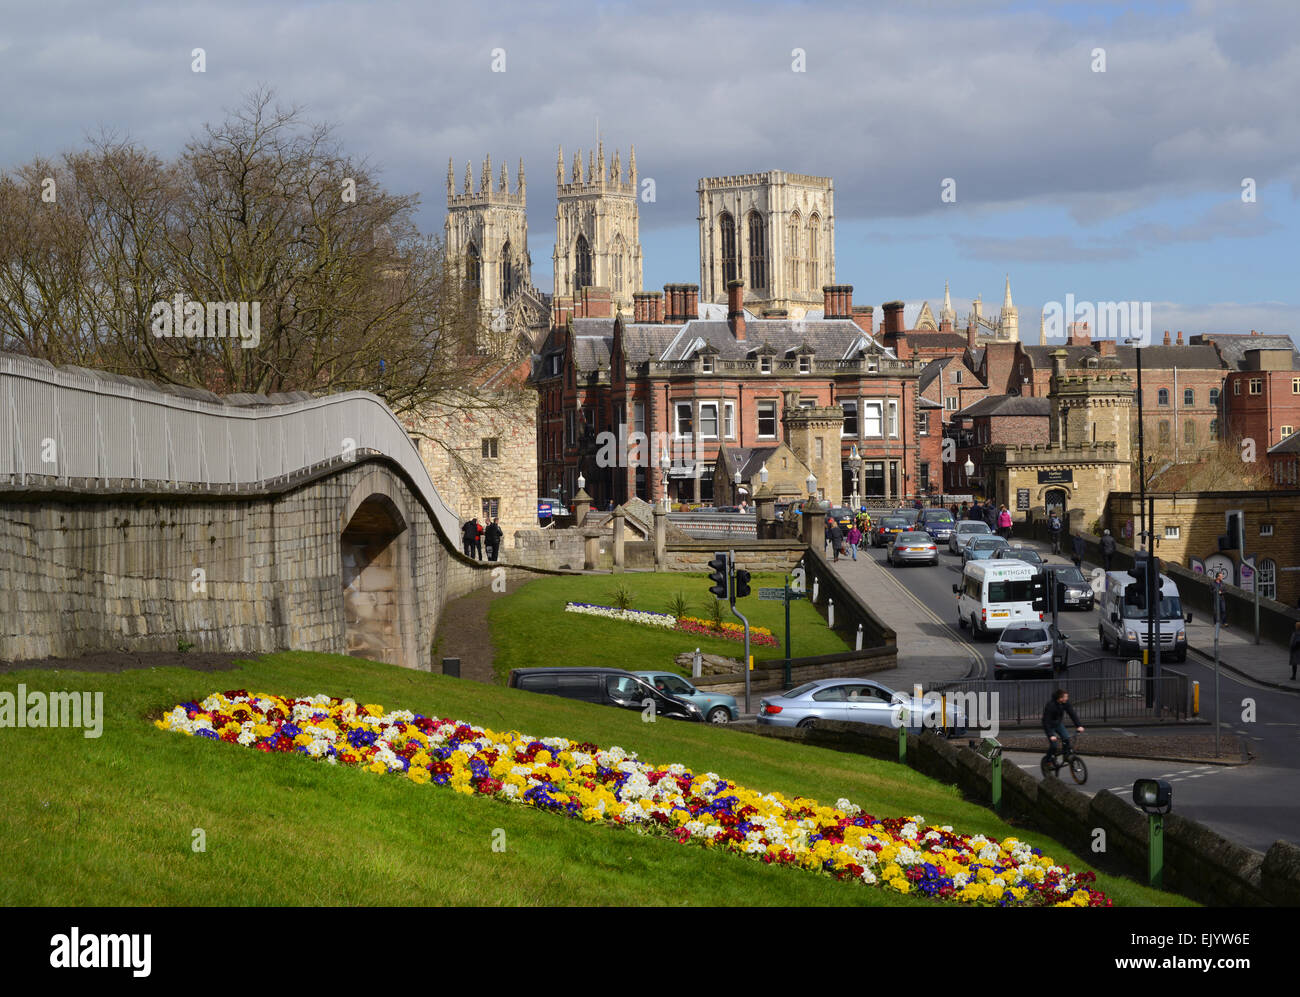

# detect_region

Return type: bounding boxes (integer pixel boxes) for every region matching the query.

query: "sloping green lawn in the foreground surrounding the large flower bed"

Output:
[0,653,1187,916]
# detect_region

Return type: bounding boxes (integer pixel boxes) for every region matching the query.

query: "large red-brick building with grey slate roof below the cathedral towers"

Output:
[533,281,937,506]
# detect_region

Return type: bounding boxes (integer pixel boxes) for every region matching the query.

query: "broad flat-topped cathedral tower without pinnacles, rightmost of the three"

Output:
[699,170,835,318]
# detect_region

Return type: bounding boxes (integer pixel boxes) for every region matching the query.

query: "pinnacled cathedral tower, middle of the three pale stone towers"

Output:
[553,142,642,315]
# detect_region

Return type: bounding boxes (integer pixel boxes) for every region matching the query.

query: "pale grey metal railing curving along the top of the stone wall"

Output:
[0,354,459,541]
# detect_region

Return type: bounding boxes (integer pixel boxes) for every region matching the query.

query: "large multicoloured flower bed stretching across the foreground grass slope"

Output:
[155,689,1110,907]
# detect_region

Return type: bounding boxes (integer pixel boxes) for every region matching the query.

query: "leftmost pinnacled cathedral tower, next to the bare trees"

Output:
[446,156,533,312]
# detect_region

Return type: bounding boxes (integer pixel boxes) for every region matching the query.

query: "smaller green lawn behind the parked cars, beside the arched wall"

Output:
[488,572,850,682]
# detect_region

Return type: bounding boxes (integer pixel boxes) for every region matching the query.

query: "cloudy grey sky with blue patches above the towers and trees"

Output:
[0,0,1300,342]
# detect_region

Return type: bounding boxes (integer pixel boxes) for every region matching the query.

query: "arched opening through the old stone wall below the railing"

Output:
[339,482,417,668]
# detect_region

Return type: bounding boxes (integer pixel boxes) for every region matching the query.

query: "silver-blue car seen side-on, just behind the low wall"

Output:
[758,679,966,734]
